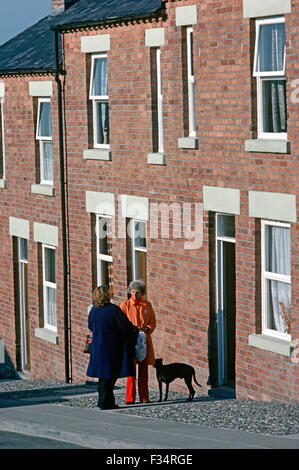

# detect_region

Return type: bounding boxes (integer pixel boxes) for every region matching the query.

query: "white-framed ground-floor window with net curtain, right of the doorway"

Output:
[262,221,291,339]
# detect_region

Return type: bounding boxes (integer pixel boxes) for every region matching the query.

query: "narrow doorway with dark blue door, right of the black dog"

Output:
[216,214,236,387]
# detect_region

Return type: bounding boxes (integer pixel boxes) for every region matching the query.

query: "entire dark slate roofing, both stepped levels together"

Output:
[0,0,163,75]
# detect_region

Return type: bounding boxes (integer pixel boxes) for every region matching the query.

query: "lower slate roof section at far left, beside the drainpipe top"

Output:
[0,14,61,74]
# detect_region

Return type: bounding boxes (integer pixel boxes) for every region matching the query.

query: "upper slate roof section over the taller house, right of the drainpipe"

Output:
[52,0,163,29]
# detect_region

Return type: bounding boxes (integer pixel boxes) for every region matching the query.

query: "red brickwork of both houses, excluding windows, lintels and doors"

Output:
[0,0,299,401]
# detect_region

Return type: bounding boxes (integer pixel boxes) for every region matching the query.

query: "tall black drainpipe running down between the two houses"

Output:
[55,30,72,383]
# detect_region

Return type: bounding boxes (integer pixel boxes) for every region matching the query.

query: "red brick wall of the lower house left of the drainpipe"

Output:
[0,76,64,380]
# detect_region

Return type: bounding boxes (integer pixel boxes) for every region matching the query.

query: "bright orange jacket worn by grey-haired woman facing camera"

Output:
[120,298,156,366]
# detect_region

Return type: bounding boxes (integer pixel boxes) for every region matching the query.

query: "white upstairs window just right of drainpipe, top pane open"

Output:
[89,54,110,148]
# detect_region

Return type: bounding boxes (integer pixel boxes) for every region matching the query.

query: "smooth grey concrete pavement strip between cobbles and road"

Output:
[0,395,299,449]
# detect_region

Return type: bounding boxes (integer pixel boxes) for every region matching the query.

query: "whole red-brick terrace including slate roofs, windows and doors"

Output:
[0,0,299,402]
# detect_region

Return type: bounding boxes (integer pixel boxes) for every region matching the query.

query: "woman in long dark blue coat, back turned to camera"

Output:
[87,286,138,410]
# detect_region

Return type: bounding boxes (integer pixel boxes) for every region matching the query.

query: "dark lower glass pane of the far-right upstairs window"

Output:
[262,80,287,133]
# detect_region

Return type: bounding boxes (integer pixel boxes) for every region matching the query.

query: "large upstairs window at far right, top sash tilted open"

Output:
[253,18,287,139]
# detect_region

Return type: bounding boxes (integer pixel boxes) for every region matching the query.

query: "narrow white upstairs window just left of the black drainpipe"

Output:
[36,98,53,184]
